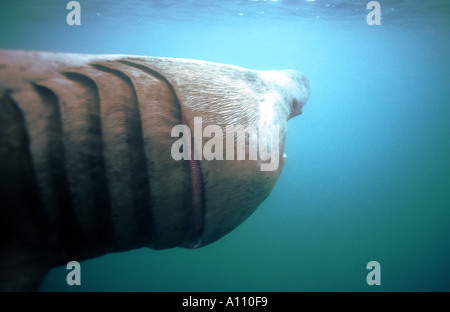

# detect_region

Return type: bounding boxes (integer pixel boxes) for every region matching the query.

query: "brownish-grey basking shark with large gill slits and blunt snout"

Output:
[0,50,311,290]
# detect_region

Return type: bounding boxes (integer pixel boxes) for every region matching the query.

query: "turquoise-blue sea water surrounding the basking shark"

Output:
[0,0,450,291]
